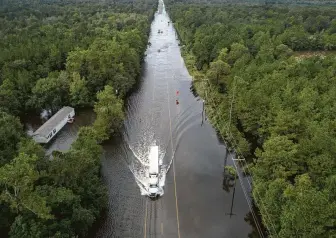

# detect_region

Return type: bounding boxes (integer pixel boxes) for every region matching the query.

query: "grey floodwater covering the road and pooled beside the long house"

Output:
[26,2,260,238]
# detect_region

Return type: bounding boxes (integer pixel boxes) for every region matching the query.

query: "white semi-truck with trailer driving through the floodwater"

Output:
[148,145,159,198]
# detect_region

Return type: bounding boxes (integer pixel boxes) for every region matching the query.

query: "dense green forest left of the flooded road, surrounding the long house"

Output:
[0,0,157,238]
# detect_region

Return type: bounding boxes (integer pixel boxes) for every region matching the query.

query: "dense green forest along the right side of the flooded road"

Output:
[167,2,336,238]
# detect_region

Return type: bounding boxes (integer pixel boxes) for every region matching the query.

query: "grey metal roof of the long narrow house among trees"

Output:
[33,107,74,137]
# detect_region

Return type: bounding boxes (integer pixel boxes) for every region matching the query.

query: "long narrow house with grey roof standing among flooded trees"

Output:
[33,107,75,143]
